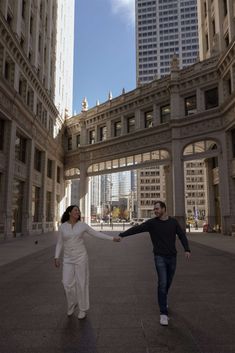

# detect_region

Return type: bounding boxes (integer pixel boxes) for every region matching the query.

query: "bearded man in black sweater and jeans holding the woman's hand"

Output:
[119,201,190,326]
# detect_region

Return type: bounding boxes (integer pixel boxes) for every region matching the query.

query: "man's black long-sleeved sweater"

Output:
[119,217,190,256]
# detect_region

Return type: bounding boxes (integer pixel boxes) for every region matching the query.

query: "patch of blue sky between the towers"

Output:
[73,0,136,113]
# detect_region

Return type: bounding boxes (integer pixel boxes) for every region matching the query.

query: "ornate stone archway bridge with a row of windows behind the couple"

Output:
[65,32,235,234]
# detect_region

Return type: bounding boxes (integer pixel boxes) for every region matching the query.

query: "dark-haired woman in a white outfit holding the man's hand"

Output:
[55,205,120,319]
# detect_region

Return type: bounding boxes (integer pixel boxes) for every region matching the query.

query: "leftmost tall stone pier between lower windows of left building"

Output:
[3,121,16,238]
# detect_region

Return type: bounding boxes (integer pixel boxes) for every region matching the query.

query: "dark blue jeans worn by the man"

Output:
[154,255,176,315]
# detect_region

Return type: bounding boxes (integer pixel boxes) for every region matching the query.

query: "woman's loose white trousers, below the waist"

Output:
[62,256,89,311]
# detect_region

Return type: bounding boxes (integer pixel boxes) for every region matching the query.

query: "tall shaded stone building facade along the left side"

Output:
[0,0,74,237]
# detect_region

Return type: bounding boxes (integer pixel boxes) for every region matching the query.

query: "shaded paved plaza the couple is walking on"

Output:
[0,232,235,353]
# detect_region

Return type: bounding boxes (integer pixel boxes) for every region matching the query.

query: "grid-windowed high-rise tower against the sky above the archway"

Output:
[136,0,198,85]
